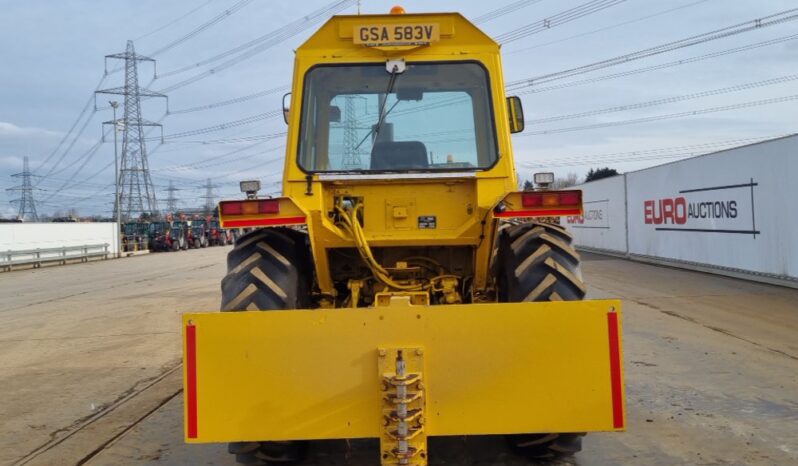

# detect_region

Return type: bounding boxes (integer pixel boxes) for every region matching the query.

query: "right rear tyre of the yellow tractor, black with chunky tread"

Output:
[496,222,586,460]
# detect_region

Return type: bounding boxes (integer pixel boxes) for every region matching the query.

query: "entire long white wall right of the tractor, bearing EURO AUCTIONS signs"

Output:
[565,135,798,286]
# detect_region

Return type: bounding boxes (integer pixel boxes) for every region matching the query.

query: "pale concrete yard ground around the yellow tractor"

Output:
[0,248,798,466]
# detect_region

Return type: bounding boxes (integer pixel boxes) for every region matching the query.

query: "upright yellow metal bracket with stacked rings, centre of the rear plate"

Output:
[378,348,427,466]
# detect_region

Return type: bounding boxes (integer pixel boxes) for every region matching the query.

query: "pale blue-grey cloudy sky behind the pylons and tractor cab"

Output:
[0,0,798,216]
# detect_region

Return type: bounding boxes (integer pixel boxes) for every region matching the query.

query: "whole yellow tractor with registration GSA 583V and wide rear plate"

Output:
[183,8,625,466]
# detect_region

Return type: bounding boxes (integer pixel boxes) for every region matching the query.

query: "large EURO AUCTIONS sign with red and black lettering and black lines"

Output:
[640,178,760,236]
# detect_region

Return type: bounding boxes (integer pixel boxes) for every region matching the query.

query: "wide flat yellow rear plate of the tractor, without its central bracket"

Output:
[183,301,625,442]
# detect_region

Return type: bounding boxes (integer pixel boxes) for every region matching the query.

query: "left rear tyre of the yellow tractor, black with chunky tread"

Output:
[221,228,313,465]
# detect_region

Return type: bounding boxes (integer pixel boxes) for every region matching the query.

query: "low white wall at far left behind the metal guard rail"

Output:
[0,223,119,255]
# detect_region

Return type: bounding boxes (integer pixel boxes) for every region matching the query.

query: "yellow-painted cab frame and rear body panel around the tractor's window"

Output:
[272,13,517,294]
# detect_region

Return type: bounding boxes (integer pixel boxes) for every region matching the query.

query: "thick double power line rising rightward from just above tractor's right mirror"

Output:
[505,8,798,90]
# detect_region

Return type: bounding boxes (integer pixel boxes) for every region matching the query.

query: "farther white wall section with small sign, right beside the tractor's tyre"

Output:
[563,176,627,254]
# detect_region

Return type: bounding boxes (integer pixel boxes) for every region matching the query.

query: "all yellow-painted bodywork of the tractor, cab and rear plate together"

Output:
[195,13,625,458]
